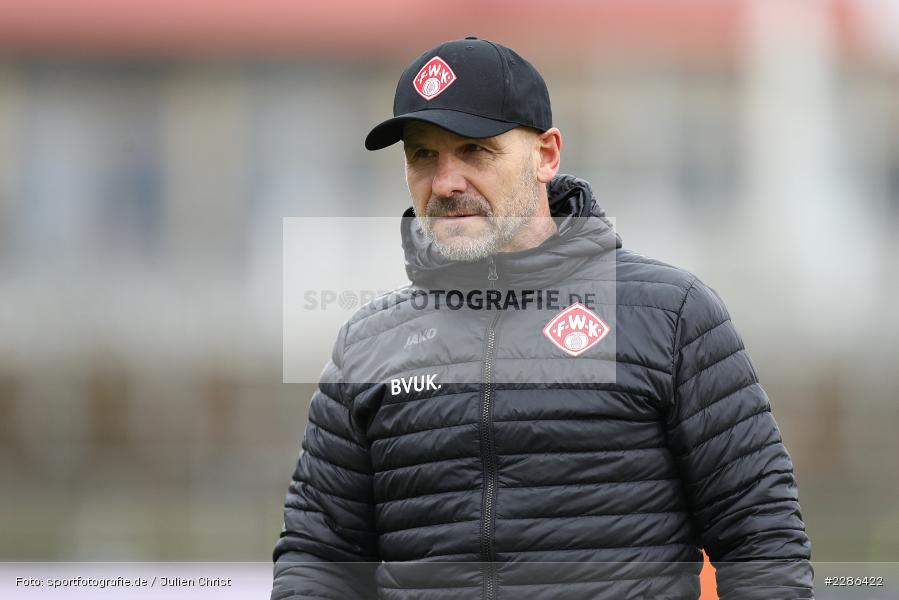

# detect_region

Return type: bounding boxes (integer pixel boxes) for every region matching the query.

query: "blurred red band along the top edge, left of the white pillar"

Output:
[0,0,745,56]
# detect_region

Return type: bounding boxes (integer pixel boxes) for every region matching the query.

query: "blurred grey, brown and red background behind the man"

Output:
[0,0,899,576]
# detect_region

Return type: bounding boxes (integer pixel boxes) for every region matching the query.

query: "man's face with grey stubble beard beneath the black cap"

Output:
[403,121,542,261]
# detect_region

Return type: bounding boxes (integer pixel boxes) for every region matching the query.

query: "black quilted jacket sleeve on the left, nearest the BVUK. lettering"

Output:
[271,327,380,600]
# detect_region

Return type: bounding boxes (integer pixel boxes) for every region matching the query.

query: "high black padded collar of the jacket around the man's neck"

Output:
[401,175,621,289]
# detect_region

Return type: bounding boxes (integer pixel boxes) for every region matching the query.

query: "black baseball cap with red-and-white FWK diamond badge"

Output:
[365,36,552,150]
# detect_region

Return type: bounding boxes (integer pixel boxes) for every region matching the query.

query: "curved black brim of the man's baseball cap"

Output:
[365,108,518,150]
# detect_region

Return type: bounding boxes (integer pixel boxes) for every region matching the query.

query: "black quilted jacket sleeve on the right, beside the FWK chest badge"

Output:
[668,280,814,600]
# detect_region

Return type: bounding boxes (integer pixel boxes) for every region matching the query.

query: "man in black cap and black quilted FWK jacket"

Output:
[272,37,813,600]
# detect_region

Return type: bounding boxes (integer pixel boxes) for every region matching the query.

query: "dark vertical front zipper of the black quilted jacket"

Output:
[481,257,501,600]
